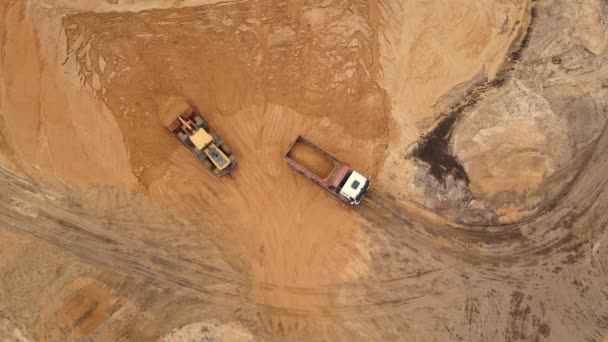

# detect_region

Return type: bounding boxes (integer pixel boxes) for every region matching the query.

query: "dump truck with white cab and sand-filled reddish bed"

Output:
[284,135,370,205]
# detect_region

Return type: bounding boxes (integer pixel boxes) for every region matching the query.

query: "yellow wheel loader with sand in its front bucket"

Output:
[161,103,237,177]
